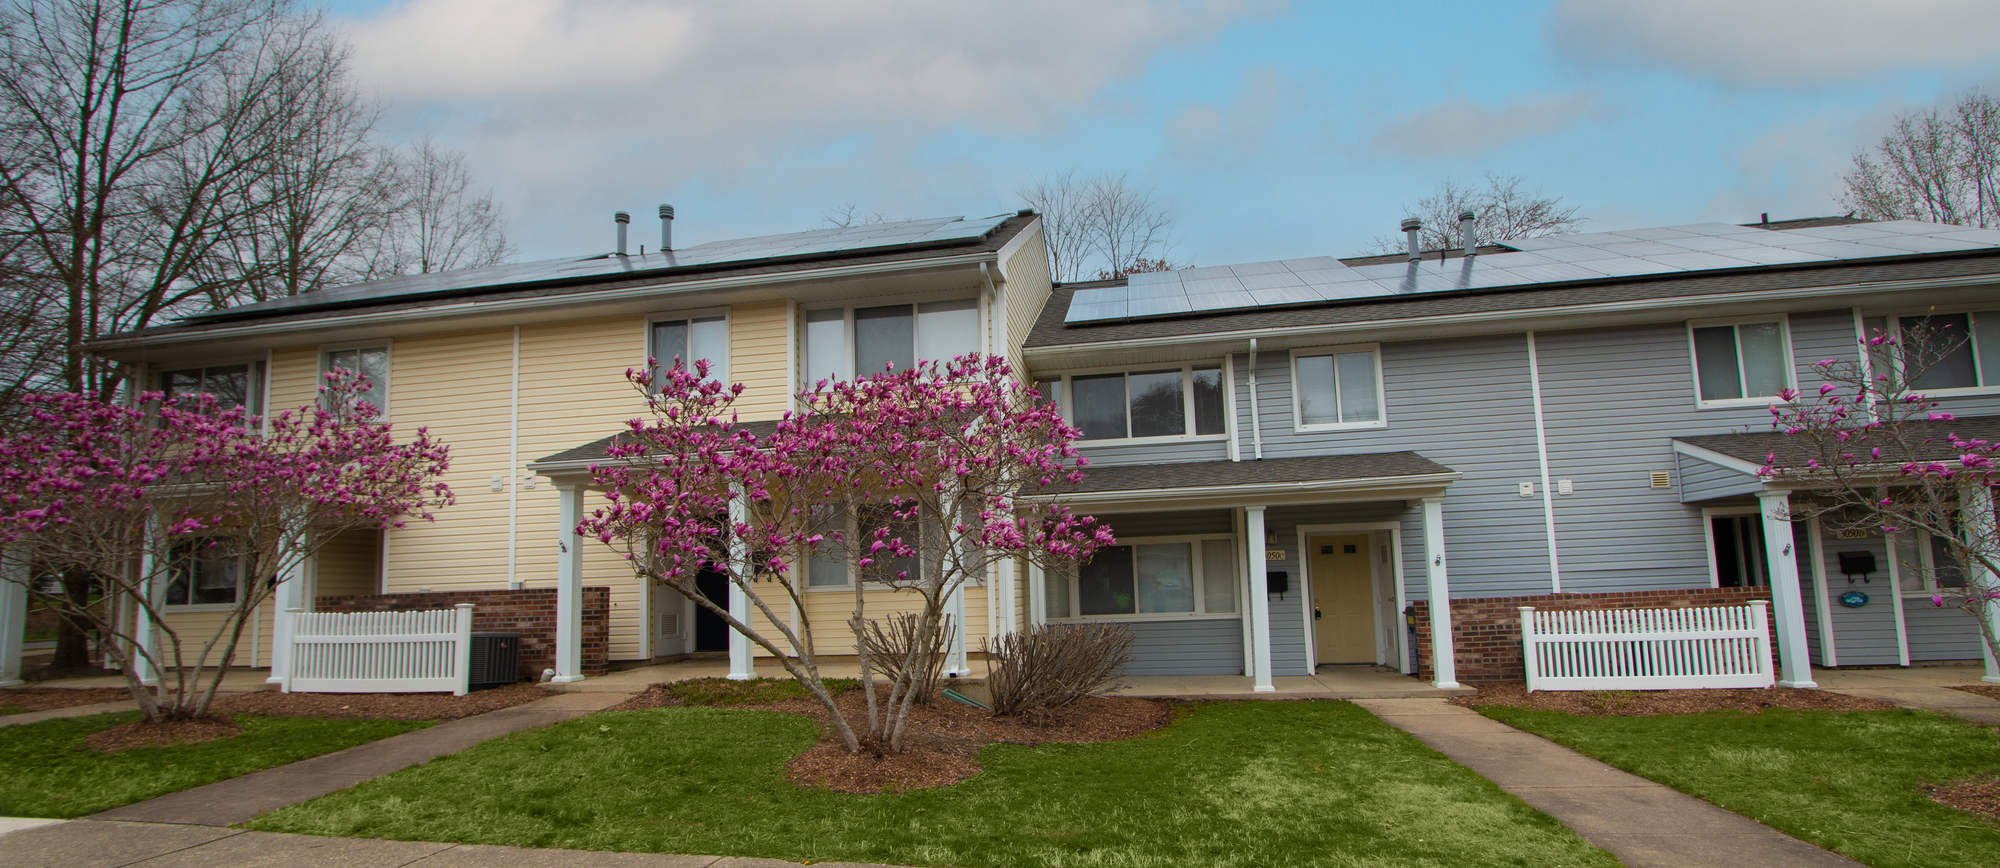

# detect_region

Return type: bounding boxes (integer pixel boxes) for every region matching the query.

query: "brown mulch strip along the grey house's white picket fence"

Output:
[1448,684,1896,718]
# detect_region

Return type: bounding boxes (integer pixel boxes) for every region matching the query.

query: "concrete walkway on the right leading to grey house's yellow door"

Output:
[1354,700,1860,868]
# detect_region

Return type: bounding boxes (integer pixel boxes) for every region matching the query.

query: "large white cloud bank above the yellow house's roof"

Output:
[350,0,1274,252]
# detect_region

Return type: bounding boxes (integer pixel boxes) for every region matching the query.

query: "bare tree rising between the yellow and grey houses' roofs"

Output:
[1016,170,1178,282]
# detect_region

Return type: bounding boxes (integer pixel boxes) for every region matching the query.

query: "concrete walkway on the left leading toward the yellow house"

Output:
[94,694,628,828]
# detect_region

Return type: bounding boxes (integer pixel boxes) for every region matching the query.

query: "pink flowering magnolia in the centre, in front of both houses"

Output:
[576,356,1112,752]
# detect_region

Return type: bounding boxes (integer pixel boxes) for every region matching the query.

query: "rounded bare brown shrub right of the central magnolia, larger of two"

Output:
[986,624,1132,718]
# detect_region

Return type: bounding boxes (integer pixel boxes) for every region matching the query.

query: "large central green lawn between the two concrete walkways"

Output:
[250,702,1616,868]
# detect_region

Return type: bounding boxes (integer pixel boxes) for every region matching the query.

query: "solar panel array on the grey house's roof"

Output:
[1064,220,2000,322]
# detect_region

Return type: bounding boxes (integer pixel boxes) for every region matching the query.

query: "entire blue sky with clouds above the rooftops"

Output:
[320,0,2000,264]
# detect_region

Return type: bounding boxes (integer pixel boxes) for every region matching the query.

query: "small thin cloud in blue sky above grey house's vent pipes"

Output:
[1372,90,1604,158]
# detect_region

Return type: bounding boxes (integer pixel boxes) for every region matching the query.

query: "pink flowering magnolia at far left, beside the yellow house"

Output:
[0,370,452,722]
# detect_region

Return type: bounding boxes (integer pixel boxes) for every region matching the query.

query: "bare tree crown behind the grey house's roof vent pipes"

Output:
[1374,172,1586,254]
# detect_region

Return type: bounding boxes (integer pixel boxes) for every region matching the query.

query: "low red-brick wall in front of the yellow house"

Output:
[316,588,612,682]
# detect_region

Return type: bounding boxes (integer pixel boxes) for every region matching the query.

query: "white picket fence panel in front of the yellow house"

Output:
[282,602,472,696]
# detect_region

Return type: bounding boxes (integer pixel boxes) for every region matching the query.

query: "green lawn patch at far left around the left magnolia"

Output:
[0,712,432,818]
